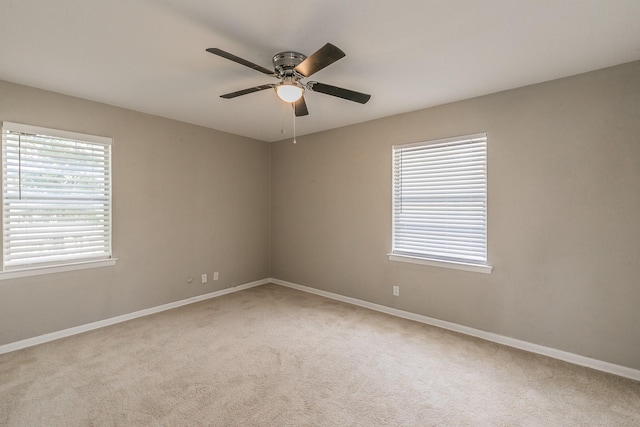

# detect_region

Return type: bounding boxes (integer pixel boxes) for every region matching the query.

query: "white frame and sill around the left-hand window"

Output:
[0,121,117,280]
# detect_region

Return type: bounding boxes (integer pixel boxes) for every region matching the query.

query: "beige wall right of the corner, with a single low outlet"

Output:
[272,62,640,369]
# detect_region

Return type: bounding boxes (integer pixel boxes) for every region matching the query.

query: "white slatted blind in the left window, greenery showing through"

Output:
[2,122,111,270]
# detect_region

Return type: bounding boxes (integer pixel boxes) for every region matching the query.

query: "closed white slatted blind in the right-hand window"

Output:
[392,134,487,264]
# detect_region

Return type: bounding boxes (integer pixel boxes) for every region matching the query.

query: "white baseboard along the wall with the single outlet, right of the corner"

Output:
[269,278,640,381]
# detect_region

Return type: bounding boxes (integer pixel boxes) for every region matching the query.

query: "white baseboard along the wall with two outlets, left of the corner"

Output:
[0,279,269,354]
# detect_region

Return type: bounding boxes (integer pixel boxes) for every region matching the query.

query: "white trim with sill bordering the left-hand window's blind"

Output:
[0,121,117,280]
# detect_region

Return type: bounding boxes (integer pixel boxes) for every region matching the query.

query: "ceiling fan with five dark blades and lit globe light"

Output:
[207,43,371,117]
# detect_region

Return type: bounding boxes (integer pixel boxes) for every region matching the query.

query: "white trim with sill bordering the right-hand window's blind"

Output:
[387,132,493,274]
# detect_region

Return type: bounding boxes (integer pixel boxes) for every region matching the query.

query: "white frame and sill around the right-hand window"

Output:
[387,133,492,274]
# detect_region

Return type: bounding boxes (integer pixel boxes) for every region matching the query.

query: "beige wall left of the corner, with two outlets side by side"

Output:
[0,82,270,345]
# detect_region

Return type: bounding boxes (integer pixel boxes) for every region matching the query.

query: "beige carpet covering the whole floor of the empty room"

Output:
[0,285,640,426]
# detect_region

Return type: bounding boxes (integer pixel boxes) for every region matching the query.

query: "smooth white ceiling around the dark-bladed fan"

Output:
[0,0,640,141]
